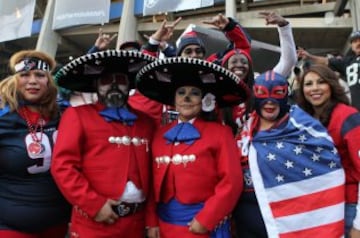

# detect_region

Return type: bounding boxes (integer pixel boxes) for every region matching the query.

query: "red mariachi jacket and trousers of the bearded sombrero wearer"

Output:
[51,103,155,238]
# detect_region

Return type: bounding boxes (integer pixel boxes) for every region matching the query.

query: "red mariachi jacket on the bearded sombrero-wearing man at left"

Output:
[51,104,154,224]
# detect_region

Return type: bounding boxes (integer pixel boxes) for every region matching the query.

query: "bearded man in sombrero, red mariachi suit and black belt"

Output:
[51,50,156,238]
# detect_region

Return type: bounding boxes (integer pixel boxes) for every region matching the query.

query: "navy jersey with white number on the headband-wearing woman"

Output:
[0,108,70,232]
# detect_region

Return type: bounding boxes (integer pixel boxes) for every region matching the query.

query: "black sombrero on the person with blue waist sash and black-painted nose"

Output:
[136,57,250,107]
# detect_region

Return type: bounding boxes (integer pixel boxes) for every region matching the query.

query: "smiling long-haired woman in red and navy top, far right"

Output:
[298,65,360,238]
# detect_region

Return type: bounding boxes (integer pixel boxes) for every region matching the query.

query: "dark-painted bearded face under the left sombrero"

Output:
[97,74,129,107]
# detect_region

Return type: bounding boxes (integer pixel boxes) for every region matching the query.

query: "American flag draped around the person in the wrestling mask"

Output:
[248,106,345,238]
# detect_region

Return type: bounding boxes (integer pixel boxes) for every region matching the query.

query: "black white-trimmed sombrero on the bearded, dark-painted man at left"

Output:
[55,50,156,92]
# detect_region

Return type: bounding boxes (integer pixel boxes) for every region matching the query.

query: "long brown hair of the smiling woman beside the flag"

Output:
[296,64,350,126]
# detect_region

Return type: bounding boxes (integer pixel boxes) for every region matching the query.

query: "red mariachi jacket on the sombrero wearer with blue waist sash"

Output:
[152,119,243,231]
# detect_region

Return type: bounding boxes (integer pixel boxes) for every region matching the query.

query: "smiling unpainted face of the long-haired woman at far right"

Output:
[303,72,331,107]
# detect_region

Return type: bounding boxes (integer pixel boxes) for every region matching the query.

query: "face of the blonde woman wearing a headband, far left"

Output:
[18,70,49,103]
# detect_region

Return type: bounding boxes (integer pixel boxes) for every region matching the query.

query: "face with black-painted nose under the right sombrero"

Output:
[175,86,202,121]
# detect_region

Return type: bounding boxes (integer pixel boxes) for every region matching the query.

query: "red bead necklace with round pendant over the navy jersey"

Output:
[21,108,45,156]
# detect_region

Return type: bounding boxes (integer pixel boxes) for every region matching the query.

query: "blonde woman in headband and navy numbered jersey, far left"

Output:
[0,50,71,238]
